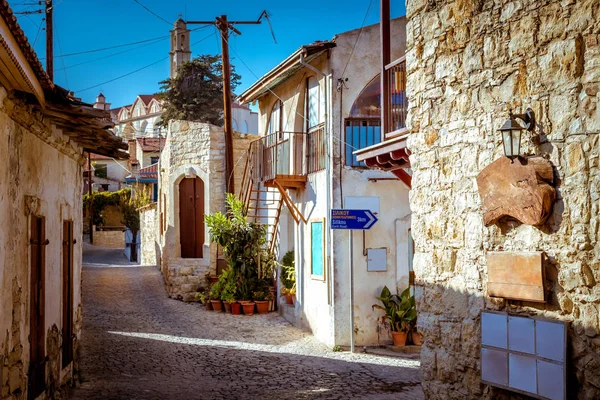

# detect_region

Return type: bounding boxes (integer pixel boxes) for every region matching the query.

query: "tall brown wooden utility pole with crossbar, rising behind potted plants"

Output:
[187,11,268,198]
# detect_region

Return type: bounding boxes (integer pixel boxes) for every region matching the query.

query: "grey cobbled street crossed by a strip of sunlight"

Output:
[71,248,423,400]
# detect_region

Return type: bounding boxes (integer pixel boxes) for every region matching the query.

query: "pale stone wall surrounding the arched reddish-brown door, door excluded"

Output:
[158,121,256,301]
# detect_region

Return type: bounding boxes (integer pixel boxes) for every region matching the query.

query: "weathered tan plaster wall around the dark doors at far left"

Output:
[0,87,85,400]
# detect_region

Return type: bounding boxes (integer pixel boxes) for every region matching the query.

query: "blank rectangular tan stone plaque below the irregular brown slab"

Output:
[487,251,545,303]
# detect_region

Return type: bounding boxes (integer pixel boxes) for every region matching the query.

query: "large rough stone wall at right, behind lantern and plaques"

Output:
[407,0,600,399]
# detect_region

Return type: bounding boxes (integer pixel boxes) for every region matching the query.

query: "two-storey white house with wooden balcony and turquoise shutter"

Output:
[239,18,411,345]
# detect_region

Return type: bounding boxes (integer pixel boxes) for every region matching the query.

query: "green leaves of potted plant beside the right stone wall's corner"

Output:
[372,286,417,332]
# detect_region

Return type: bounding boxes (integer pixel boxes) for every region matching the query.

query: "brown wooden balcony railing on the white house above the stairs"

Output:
[249,126,326,182]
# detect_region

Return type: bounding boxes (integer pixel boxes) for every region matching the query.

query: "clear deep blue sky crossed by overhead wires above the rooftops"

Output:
[15,0,405,107]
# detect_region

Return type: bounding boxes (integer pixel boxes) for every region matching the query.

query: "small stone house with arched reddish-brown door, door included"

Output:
[148,121,256,301]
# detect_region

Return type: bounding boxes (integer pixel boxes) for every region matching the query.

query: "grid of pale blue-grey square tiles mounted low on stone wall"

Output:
[481,312,567,400]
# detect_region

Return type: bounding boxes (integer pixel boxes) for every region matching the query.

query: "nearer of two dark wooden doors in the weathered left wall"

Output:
[28,216,48,399]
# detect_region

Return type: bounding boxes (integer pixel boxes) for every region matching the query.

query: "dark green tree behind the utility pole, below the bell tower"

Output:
[158,54,241,126]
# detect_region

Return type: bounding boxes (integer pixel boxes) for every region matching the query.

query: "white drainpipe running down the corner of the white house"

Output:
[300,52,333,305]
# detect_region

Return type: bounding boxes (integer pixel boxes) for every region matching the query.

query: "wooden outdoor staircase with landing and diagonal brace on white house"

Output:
[239,137,307,253]
